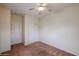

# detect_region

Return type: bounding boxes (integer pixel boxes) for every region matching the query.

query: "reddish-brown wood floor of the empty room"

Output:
[2,42,74,56]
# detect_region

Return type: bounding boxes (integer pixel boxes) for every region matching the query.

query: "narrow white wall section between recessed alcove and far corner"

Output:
[24,14,39,45]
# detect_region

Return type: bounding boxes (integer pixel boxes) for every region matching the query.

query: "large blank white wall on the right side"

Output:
[40,5,79,55]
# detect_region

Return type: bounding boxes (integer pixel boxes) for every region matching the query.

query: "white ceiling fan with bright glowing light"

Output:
[29,3,51,15]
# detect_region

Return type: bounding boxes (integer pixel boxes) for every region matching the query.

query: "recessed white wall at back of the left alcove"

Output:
[11,14,23,44]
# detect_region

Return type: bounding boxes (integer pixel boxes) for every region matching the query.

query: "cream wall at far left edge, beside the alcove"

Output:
[0,6,11,52]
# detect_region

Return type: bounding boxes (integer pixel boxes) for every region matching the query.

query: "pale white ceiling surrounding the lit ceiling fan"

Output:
[1,3,72,17]
